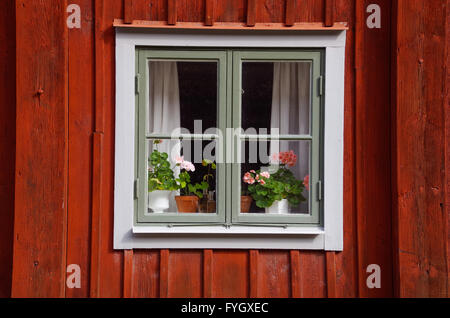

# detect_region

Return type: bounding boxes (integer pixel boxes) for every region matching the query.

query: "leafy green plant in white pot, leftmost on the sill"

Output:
[148,140,178,213]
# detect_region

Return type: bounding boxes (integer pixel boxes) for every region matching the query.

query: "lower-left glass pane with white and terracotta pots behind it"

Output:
[147,139,217,214]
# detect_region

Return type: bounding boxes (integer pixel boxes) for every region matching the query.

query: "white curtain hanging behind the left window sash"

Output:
[147,61,181,212]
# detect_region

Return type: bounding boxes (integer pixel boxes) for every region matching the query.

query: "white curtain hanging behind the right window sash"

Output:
[271,62,311,212]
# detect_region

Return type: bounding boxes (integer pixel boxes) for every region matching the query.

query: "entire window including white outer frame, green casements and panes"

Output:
[114,29,345,250]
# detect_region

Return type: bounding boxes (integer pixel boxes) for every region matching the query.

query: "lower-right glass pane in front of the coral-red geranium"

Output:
[241,140,310,215]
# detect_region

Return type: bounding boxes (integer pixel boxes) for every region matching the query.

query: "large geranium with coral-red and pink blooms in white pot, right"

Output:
[244,150,306,214]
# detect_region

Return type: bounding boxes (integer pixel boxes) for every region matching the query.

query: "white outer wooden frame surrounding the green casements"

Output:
[114,27,346,251]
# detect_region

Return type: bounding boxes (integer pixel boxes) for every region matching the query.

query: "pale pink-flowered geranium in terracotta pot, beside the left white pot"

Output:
[175,157,207,213]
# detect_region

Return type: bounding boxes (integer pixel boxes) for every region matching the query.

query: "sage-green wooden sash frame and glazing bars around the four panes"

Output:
[137,49,323,226]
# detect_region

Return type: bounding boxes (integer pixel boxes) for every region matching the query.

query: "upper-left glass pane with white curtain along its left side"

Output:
[147,61,218,135]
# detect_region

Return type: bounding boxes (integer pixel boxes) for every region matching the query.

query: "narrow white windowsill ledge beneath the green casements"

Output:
[133,225,325,235]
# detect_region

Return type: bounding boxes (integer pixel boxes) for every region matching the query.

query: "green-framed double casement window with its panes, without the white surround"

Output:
[135,48,323,227]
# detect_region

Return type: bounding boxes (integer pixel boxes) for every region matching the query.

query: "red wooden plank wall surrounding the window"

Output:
[0,0,450,297]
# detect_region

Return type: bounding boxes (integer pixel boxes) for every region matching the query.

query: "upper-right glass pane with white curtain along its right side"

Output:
[242,61,312,135]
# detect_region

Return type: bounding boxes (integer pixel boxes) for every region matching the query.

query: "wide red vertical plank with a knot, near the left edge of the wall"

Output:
[12,0,68,297]
